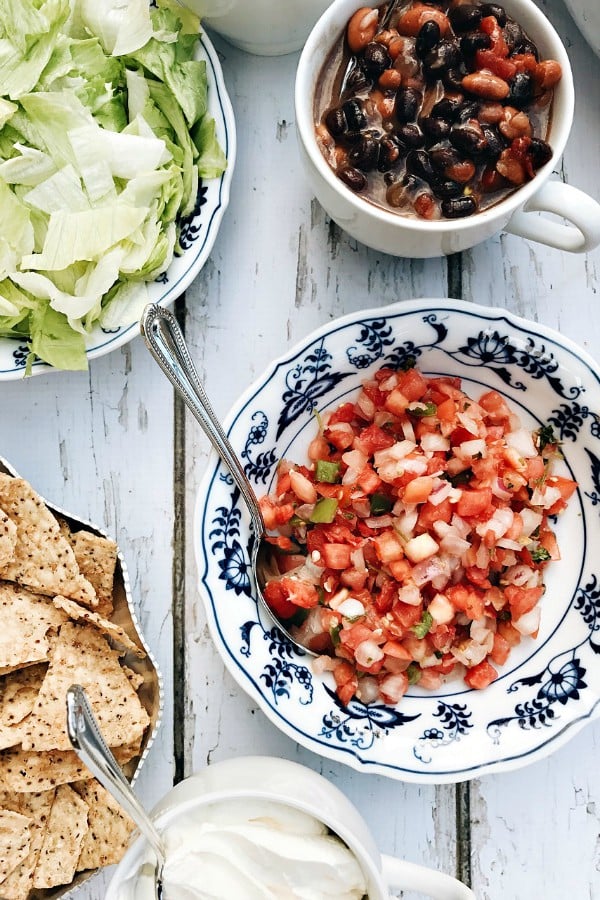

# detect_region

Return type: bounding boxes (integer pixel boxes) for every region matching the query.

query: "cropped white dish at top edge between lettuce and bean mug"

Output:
[188,0,331,56]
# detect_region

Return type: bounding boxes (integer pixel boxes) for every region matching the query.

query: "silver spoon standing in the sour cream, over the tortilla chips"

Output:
[67,684,165,900]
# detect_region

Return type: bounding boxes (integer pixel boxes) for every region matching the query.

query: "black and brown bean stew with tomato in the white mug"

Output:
[315,0,562,219]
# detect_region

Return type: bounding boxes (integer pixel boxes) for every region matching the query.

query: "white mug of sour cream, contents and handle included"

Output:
[106,757,474,900]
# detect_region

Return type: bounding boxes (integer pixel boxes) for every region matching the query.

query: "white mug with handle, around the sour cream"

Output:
[106,756,475,900]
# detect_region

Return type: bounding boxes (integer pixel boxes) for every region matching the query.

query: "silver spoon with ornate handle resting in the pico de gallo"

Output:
[140,303,317,656]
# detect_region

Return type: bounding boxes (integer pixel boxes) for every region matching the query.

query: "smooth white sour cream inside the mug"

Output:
[116,798,367,900]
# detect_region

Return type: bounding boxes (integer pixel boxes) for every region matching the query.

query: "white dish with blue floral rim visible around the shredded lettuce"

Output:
[0,33,236,381]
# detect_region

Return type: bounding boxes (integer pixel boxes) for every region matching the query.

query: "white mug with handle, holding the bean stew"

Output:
[295,0,600,257]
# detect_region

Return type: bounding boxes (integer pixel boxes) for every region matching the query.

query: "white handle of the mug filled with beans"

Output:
[504,181,600,253]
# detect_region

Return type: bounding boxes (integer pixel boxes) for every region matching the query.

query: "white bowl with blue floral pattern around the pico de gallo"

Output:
[194,300,600,784]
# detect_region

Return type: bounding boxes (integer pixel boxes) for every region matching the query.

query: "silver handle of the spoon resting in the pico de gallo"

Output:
[140,303,264,536]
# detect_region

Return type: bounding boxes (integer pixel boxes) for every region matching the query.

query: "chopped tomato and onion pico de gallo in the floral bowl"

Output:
[260,367,577,704]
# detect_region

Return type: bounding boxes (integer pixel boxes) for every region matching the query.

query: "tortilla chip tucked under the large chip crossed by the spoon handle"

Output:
[0,742,140,792]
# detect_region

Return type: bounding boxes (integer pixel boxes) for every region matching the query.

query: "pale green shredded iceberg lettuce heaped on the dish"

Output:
[0,0,226,369]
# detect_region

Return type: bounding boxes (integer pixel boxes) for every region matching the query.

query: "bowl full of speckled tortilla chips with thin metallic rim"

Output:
[0,459,163,900]
